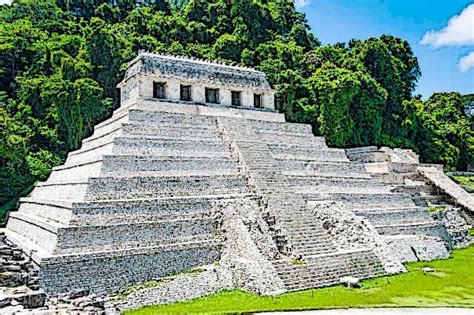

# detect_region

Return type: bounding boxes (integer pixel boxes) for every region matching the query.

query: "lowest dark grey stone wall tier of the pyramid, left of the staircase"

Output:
[39,242,220,293]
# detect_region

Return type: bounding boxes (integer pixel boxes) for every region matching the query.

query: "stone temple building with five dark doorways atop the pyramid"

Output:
[118,53,275,110]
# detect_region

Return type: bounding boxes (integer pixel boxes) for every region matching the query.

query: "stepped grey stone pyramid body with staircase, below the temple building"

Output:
[6,100,452,293]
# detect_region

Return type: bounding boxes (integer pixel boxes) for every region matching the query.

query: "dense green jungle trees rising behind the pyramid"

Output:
[0,0,473,217]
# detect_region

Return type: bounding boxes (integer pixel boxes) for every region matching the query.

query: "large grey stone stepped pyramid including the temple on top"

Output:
[3,53,473,309]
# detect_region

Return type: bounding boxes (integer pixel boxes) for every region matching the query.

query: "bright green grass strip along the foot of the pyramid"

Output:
[126,246,474,314]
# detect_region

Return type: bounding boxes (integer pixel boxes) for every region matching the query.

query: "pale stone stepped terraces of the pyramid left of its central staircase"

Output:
[6,104,255,293]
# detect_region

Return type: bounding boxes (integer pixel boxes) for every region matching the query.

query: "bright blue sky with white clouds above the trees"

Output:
[296,0,474,98]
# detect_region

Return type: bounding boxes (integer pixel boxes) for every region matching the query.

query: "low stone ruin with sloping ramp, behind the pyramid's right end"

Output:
[346,147,474,252]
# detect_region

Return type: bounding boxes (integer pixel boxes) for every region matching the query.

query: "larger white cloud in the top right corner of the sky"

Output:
[420,4,474,47]
